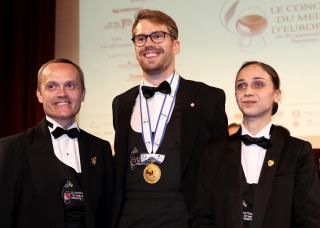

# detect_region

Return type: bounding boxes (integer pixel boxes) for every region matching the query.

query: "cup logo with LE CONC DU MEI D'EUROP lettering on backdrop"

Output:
[220,0,320,52]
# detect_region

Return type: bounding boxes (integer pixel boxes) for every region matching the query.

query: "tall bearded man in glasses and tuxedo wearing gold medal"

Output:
[113,9,227,228]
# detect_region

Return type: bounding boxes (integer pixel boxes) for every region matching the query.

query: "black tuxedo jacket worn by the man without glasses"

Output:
[0,120,113,228]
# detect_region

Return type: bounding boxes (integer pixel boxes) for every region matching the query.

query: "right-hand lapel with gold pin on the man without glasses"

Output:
[78,131,100,227]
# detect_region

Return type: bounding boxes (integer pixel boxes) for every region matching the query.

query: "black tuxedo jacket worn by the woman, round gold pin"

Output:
[192,126,320,228]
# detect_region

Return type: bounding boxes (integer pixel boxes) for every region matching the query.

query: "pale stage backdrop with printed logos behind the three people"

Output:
[80,0,320,148]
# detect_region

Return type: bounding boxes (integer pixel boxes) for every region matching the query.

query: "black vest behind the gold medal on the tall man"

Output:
[118,96,188,228]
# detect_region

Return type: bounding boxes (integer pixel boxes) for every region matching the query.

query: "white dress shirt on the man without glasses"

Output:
[46,116,81,173]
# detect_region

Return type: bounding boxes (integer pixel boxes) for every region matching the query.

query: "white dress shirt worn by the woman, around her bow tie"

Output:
[241,122,272,184]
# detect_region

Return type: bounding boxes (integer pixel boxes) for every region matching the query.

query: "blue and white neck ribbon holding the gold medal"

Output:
[139,72,179,164]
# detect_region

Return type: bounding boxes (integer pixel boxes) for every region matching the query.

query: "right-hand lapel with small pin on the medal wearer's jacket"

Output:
[177,77,200,174]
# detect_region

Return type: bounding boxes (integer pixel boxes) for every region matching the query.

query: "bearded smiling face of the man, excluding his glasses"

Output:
[134,19,180,79]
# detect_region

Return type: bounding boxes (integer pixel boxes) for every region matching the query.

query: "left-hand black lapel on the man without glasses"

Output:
[28,120,64,228]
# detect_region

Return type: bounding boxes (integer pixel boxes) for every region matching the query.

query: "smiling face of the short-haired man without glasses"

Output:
[37,63,85,128]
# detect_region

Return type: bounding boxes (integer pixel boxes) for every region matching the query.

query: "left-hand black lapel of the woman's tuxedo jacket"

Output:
[226,136,242,228]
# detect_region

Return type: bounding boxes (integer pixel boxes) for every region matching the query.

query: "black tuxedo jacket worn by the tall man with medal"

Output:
[113,77,227,225]
